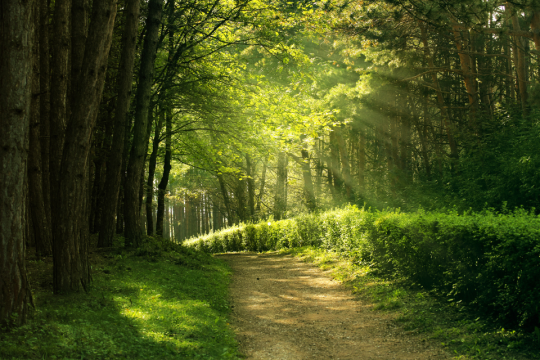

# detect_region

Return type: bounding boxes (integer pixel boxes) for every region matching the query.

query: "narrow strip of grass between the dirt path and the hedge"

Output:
[280,247,540,360]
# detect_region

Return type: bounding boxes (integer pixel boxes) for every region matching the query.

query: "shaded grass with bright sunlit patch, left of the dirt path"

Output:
[0,238,239,359]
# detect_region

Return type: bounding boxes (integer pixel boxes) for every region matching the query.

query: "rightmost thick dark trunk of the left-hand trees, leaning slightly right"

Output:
[124,0,163,247]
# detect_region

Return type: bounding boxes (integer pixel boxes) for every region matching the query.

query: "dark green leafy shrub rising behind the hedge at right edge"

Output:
[447,109,540,210]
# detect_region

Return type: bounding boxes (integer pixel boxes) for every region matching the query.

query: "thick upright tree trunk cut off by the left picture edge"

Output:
[0,0,35,326]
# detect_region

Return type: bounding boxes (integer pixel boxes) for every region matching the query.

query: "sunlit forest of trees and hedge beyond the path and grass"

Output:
[0,0,540,358]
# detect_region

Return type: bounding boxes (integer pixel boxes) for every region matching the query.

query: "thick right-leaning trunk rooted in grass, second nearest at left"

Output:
[53,0,116,293]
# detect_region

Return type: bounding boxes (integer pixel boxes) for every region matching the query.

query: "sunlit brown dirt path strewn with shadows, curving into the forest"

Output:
[219,253,449,360]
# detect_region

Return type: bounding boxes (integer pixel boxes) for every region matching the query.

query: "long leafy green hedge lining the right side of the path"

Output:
[184,207,540,329]
